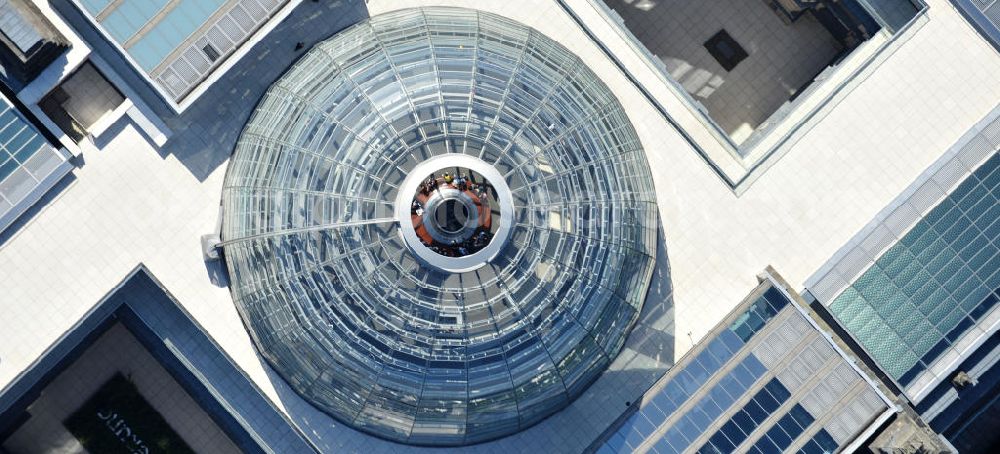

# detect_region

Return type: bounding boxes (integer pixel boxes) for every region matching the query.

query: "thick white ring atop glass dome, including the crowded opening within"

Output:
[396,153,514,273]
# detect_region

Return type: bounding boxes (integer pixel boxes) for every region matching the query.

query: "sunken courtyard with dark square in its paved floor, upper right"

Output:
[605,0,916,145]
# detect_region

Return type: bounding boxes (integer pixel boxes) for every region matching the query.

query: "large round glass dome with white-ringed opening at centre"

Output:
[223,8,657,445]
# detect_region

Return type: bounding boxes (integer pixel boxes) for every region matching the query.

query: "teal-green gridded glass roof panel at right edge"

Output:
[830,153,1000,386]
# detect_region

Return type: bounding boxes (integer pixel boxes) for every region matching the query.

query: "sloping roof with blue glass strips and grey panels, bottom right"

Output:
[598,284,888,454]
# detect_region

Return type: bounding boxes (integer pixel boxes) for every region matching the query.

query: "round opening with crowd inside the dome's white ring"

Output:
[404,167,500,257]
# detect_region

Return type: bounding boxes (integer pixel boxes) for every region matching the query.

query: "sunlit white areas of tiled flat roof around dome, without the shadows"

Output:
[0,0,1000,448]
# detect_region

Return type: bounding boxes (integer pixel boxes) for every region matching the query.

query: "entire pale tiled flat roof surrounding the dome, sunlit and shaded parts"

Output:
[0,0,1000,452]
